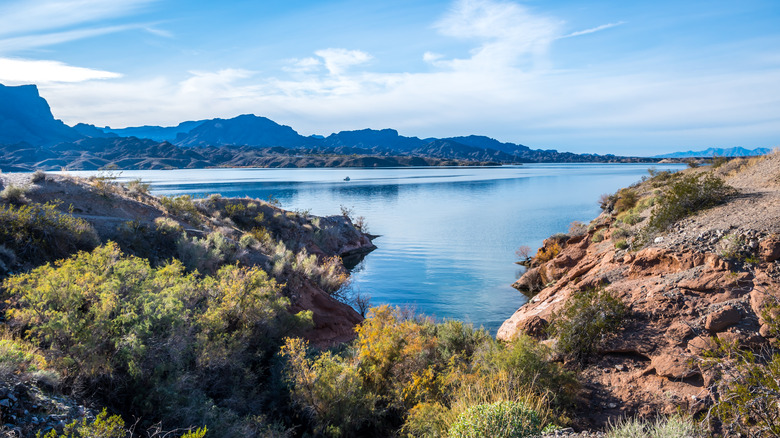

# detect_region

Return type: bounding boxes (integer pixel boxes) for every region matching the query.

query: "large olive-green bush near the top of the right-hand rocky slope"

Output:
[648,173,736,231]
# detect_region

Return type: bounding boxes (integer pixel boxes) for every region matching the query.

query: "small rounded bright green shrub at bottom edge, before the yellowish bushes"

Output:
[449,401,542,438]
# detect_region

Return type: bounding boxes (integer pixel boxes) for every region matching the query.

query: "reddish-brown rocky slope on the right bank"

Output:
[498,152,780,428]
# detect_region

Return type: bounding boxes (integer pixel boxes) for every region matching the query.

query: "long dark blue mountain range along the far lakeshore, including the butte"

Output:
[0,81,760,171]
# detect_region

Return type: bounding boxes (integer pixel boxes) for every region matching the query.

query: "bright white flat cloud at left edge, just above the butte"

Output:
[0,58,122,85]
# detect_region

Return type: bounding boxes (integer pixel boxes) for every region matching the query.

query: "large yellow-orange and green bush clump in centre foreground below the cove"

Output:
[283,306,576,436]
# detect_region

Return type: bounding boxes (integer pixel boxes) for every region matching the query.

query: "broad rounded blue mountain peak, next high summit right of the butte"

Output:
[174,114,321,147]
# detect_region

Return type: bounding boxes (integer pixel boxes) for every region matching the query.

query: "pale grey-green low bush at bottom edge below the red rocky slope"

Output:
[606,415,705,438]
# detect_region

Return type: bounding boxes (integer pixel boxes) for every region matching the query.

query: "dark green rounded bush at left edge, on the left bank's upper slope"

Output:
[0,203,100,264]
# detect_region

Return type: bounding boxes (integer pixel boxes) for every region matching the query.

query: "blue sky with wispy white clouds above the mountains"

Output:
[0,0,780,155]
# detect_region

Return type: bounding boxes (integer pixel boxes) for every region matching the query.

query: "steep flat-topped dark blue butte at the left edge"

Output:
[0,84,84,145]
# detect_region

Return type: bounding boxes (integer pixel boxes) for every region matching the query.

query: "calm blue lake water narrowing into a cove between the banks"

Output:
[72,164,679,332]
